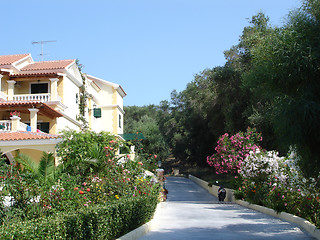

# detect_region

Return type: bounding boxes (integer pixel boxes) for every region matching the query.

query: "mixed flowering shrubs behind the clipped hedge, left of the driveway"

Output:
[0,130,159,235]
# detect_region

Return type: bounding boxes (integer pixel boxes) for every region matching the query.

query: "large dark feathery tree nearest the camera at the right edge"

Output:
[243,0,320,176]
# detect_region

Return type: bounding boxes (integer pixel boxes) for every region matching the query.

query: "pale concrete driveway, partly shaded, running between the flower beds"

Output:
[140,177,314,240]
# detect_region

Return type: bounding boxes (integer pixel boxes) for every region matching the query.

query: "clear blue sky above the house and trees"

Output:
[0,0,301,106]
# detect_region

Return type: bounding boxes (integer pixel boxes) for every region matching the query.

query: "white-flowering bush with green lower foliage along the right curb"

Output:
[235,148,320,227]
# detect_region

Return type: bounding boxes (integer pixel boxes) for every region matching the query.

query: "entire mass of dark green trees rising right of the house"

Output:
[125,0,320,176]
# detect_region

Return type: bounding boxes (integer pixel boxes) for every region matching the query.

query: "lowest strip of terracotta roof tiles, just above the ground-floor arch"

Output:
[0,131,61,141]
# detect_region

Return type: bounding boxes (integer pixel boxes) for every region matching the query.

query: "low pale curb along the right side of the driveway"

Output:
[189,175,320,240]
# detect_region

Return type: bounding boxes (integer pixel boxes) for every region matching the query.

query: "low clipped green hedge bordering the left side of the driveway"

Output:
[0,195,158,240]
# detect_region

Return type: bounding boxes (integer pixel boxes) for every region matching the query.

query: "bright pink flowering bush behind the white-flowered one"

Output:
[207,127,262,174]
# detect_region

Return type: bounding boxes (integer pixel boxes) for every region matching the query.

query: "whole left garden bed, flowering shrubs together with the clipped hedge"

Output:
[0,130,160,239]
